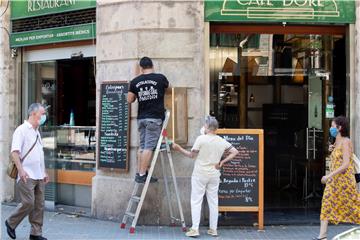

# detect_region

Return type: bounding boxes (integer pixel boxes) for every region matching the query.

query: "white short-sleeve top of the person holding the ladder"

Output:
[192,134,232,176]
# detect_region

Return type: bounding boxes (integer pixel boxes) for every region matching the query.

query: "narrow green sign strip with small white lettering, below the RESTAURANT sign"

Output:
[10,23,96,48]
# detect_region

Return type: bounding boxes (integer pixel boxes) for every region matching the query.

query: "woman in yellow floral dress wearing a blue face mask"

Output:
[314,117,360,240]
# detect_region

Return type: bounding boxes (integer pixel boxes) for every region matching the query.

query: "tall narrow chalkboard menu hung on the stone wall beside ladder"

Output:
[98,82,130,171]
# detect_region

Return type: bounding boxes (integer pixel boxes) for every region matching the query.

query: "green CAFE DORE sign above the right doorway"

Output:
[205,0,355,23]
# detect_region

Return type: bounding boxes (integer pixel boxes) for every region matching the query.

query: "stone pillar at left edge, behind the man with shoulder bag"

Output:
[0,1,19,202]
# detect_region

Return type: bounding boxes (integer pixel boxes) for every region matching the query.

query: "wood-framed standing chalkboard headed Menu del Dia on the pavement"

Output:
[217,129,264,229]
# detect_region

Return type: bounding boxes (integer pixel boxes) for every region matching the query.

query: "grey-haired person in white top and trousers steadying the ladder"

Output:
[173,116,238,237]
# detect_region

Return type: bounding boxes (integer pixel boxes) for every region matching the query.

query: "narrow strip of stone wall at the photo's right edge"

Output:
[350,1,360,154]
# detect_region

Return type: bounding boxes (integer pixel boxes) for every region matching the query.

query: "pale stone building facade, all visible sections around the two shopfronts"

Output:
[0,0,360,224]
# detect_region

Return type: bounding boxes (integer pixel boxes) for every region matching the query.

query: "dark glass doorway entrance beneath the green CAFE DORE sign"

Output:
[210,24,347,218]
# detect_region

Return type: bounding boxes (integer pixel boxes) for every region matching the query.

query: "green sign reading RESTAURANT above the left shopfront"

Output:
[10,0,96,20]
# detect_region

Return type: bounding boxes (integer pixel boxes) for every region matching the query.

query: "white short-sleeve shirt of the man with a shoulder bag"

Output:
[11,121,45,180]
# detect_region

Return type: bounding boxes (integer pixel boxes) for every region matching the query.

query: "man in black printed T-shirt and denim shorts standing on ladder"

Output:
[127,57,169,183]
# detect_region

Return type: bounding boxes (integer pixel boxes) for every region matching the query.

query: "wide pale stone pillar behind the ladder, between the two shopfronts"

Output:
[92,0,208,225]
